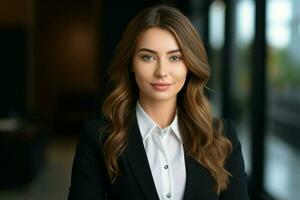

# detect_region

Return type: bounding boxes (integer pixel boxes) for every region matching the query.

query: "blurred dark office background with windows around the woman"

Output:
[0,0,300,200]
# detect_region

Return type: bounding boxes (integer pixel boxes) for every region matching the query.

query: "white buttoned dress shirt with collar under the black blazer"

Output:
[136,102,186,200]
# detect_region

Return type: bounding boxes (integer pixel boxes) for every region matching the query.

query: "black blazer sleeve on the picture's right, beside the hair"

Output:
[220,120,249,200]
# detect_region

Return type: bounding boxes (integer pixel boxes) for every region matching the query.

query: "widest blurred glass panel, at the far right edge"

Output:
[264,0,300,200]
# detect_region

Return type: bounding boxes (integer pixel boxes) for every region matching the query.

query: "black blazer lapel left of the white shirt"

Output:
[125,117,159,200]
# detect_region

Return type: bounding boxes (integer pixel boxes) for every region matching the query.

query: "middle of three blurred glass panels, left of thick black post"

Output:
[231,0,254,175]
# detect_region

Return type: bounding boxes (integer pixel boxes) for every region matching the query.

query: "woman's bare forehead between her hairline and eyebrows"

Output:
[136,27,179,51]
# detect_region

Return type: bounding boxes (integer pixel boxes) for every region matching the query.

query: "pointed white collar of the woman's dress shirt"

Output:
[136,102,182,143]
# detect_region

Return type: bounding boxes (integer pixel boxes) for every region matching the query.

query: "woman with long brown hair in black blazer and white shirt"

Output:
[69,3,248,200]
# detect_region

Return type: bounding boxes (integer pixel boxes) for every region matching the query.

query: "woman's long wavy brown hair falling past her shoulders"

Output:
[102,5,232,193]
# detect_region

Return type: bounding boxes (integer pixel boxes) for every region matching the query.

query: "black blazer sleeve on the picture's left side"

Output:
[68,121,106,200]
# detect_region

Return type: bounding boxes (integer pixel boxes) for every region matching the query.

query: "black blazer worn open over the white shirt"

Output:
[68,116,248,200]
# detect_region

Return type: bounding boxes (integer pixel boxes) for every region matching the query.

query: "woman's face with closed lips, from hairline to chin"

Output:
[132,27,188,102]
